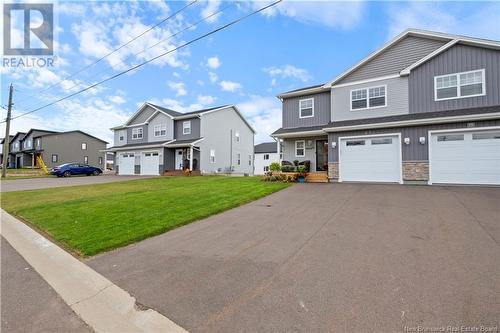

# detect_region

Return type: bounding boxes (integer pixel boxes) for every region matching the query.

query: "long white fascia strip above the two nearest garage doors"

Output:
[323,112,500,133]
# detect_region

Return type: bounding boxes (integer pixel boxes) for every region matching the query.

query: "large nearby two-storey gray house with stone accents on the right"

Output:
[272,29,500,185]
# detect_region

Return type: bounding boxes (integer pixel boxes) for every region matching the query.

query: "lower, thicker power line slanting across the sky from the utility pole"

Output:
[4,0,282,119]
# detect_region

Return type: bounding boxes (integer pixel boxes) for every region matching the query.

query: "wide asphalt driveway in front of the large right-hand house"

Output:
[89,184,500,332]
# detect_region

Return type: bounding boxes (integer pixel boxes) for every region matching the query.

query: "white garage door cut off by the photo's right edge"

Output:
[429,130,500,185]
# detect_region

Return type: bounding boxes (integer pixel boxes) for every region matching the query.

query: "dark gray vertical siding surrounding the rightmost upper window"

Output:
[409,45,500,113]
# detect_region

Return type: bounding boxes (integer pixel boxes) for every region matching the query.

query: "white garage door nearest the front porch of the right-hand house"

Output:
[339,135,401,182]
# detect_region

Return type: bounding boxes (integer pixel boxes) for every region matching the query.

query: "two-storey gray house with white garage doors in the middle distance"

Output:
[103,103,255,175]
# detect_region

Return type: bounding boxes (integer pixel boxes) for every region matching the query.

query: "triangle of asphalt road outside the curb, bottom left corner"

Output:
[1,238,92,333]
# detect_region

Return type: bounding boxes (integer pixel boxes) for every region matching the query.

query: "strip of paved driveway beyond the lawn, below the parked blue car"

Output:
[0,175,152,192]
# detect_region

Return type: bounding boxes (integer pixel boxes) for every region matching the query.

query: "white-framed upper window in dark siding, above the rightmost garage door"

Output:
[434,69,486,101]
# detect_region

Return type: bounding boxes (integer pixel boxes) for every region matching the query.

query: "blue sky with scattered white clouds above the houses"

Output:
[0,0,500,144]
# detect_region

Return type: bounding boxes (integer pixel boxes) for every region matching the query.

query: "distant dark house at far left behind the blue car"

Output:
[1,128,107,168]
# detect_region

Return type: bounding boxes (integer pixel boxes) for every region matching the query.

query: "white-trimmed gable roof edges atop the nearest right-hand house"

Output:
[324,29,500,88]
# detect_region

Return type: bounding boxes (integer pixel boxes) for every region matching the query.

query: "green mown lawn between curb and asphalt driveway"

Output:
[1,176,290,256]
